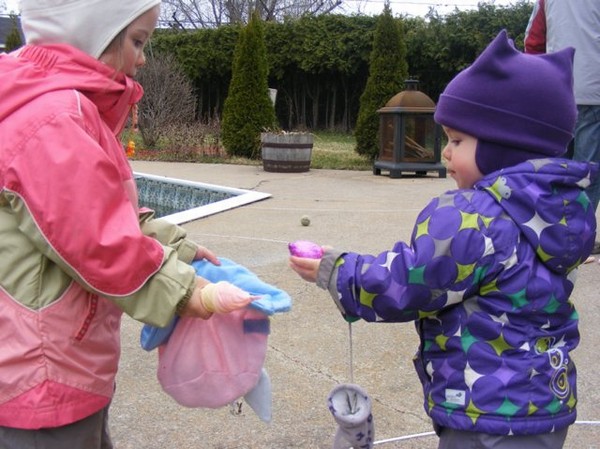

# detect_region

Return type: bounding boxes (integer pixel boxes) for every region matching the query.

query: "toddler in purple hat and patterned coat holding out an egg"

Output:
[290,31,597,449]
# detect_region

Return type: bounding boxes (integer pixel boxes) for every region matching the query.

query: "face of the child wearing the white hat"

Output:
[100,6,160,77]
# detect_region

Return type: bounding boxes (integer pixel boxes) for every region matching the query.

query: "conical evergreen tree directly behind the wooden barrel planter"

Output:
[221,13,276,159]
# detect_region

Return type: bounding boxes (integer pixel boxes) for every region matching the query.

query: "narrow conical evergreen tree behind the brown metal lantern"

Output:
[354,1,408,159]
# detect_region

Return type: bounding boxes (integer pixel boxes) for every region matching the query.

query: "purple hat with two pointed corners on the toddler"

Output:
[434,30,577,174]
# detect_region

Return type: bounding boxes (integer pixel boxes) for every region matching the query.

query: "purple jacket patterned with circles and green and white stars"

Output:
[318,159,597,434]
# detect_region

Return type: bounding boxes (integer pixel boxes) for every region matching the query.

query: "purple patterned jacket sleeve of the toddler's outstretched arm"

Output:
[317,197,500,322]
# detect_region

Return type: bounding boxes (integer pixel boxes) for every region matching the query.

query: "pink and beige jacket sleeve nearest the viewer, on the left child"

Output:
[5,100,195,325]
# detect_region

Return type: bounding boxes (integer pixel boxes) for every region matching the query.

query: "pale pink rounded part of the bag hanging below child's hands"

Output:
[157,308,270,408]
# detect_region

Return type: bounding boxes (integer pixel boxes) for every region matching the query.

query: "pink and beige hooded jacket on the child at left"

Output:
[0,45,197,429]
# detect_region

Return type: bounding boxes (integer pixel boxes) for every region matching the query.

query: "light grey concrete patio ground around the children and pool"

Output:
[111,161,600,449]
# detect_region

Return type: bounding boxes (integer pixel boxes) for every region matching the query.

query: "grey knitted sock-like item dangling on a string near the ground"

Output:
[327,384,375,449]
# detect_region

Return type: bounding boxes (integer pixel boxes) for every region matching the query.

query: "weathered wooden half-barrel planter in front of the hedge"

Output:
[260,133,313,173]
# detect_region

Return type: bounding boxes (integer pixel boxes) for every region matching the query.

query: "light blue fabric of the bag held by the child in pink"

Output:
[140,257,292,351]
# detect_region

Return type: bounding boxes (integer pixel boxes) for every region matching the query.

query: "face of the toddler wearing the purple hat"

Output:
[442,126,483,189]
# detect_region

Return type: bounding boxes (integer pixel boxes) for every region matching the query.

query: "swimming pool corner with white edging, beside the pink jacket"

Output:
[134,172,271,224]
